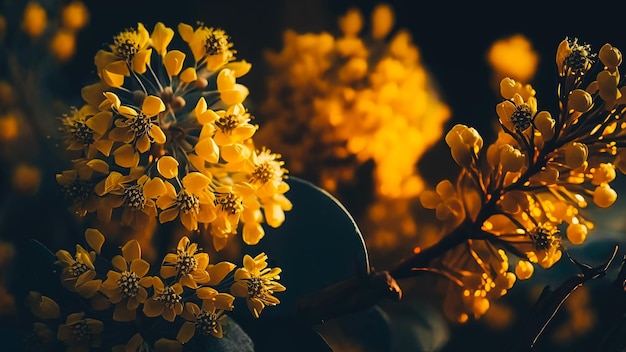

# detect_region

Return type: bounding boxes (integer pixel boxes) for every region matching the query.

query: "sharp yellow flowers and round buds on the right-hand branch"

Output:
[420,39,626,321]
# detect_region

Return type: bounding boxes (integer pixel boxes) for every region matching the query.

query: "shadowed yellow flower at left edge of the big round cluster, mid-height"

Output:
[61,105,113,159]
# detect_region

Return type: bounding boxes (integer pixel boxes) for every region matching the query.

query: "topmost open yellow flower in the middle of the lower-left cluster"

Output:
[161,236,210,289]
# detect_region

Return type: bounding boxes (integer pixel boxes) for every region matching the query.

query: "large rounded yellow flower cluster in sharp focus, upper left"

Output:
[57,22,291,250]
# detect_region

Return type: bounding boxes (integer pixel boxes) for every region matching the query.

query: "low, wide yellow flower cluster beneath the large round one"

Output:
[26,228,285,351]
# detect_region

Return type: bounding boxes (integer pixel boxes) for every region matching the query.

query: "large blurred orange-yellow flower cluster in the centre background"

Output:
[258,4,450,198]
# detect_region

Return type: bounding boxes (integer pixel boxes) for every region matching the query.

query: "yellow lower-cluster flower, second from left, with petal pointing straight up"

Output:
[100,240,153,321]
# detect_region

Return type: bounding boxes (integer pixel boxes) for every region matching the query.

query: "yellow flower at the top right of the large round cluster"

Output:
[178,23,235,71]
